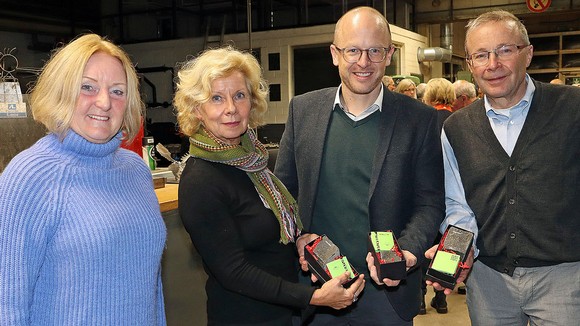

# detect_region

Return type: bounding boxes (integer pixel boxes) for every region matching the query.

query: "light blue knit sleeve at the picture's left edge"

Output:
[0,153,59,326]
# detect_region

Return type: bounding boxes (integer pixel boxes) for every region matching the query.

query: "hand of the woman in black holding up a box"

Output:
[310,272,365,310]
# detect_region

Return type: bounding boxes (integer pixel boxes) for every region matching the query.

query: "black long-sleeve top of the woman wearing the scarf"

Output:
[179,158,315,325]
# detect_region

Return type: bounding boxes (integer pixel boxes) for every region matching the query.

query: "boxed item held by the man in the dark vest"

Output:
[426,225,474,289]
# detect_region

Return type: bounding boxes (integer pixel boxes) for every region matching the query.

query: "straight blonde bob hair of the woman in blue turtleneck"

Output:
[30,34,143,141]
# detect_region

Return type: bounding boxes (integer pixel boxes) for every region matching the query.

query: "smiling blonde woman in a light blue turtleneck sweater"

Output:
[0,34,166,326]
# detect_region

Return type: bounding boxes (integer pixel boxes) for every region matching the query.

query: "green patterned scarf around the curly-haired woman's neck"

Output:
[189,127,302,244]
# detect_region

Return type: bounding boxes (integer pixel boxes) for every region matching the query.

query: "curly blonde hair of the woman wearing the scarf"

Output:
[173,46,268,136]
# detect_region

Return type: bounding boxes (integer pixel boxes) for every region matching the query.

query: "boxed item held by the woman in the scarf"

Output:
[304,235,358,288]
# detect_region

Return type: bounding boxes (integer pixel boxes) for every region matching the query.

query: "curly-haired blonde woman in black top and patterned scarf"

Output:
[174,47,364,326]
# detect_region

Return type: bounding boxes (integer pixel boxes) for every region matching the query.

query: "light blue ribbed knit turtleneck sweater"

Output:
[0,131,166,326]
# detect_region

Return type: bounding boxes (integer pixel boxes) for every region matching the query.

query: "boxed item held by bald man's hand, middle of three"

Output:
[368,230,407,280]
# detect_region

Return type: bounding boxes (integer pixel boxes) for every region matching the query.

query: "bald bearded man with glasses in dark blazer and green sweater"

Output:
[275,7,444,325]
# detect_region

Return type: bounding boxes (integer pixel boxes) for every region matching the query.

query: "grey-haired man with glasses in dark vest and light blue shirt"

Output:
[426,11,580,325]
